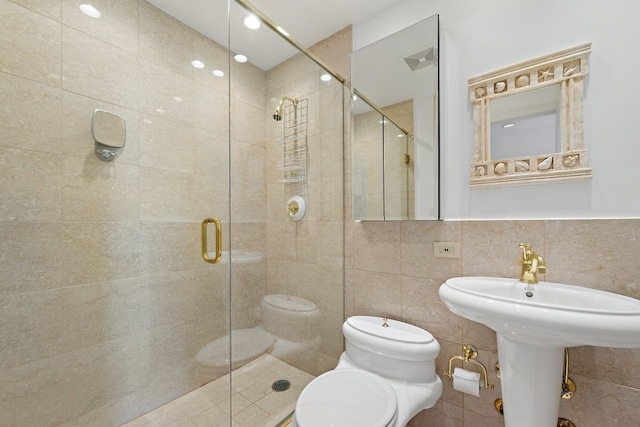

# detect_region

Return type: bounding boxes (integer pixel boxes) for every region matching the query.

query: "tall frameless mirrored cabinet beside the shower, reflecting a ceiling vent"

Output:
[351,15,440,220]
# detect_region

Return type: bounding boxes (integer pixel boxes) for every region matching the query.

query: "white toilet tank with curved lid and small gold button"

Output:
[342,316,440,383]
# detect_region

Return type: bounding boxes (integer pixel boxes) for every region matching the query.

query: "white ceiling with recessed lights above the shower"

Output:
[148,0,402,70]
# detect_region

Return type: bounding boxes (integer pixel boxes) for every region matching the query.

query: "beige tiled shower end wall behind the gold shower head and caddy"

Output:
[266,40,344,375]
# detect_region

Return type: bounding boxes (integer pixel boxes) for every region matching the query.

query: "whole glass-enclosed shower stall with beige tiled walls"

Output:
[0,0,350,427]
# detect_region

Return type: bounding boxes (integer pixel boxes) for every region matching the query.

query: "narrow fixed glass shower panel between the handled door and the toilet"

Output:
[229,1,350,427]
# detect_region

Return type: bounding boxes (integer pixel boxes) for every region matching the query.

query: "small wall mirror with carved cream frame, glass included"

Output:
[468,43,591,187]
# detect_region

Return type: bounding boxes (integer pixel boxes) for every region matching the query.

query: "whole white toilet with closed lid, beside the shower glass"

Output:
[292,316,442,427]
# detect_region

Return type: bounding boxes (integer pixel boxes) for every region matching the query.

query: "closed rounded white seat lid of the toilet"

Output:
[294,368,398,427]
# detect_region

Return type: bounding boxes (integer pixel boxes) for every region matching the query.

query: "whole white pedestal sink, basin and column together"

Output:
[440,277,640,427]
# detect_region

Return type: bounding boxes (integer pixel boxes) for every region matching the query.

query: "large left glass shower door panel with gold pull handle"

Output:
[0,0,235,426]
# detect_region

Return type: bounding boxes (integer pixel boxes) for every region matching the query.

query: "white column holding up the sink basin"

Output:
[497,333,564,427]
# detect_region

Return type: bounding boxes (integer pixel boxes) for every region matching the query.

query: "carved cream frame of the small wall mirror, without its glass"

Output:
[468,43,591,187]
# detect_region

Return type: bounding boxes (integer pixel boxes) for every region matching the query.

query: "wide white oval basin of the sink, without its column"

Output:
[440,277,640,348]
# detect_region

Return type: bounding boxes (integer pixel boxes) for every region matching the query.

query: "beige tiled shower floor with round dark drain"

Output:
[122,354,314,427]
